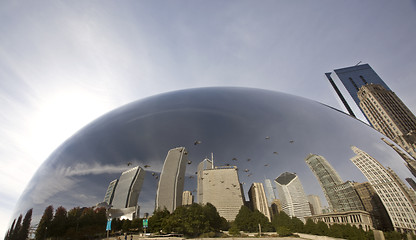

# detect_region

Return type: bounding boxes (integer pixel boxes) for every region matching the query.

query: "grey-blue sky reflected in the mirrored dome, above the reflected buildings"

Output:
[11,88,412,223]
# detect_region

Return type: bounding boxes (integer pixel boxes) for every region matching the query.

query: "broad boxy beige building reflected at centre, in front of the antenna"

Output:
[200,166,245,221]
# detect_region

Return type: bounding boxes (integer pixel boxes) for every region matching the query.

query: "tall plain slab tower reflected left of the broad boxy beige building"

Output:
[155,147,188,212]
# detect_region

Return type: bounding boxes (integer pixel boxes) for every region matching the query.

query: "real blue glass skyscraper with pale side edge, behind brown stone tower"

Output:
[325,64,390,121]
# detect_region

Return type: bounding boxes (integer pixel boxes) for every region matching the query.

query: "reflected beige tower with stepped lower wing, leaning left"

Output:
[305,154,364,212]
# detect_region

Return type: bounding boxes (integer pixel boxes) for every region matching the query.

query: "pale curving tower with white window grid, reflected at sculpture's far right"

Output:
[351,146,416,233]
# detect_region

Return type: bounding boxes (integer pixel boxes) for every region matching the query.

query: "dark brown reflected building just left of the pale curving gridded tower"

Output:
[353,182,393,231]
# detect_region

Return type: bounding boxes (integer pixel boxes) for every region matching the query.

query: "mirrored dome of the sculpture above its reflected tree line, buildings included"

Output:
[11,87,416,233]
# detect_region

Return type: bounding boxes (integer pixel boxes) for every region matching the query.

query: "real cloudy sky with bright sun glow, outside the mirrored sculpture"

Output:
[0,0,416,236]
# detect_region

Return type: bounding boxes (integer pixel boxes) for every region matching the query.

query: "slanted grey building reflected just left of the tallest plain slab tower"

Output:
[112,166,145,209]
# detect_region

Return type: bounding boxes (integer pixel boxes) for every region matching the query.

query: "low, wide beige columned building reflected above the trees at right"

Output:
[305,210,373,231]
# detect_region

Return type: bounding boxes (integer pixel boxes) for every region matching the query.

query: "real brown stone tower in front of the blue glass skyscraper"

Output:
[358,84,416,158]
